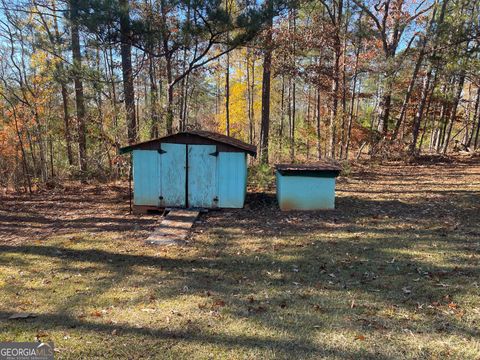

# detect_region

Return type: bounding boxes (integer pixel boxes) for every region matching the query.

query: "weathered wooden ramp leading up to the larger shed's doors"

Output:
[145,209,200,245]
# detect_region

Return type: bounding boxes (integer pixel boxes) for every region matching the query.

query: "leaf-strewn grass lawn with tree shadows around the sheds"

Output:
[0,161,480,359]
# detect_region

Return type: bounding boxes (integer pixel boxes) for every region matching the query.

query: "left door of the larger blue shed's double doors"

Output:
[160,143,187,207]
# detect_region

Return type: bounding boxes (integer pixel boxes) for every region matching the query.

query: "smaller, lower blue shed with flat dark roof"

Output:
[275,161,341,210]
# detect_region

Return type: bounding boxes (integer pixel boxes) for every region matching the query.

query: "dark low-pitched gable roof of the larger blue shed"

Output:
[120,130,257,156]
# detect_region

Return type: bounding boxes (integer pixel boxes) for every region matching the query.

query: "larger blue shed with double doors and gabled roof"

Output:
[120,131,257,211]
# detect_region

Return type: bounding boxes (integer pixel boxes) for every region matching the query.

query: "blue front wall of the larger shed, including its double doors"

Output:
[133,143,247,208]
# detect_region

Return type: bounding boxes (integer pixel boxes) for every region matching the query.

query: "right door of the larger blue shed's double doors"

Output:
[187,145,218,208]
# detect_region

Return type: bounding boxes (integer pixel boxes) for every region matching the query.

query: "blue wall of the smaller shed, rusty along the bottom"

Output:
[276,171,335,210]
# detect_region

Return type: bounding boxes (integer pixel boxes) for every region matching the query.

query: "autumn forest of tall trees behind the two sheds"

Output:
[0,0,480,190]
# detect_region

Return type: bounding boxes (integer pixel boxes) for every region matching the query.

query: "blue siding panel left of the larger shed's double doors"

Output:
[133,150,160,206]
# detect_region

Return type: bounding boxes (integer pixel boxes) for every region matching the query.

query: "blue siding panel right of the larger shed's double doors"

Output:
[217,152,247,208]
